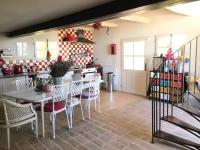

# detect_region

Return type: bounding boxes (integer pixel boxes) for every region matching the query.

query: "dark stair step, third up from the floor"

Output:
[175,103,200,118]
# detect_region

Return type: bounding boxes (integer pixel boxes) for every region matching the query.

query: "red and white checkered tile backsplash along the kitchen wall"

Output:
[6,28,93,71]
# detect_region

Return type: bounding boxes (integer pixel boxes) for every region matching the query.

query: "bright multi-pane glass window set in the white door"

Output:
[123,40,146,70]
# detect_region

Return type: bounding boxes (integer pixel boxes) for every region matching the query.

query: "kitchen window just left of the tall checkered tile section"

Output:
[35,40,58,59]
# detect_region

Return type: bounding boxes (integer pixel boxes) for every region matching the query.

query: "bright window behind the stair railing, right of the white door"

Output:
[156,34,186,56]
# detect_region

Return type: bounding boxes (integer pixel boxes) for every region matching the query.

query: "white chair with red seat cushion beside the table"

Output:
[37,83,70,139]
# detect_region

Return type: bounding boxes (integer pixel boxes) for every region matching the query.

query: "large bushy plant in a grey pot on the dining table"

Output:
[49,59,72,85]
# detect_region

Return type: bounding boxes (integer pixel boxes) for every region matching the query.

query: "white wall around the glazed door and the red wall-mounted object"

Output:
[93,15,200,90]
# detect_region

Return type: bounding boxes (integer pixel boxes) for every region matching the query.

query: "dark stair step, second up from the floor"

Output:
[162,116,200,134]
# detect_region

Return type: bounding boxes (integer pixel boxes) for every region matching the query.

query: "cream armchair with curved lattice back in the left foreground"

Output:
[0,99,38,149]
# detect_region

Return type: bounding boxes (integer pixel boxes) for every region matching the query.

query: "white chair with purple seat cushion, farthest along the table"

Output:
[81,78,101,119]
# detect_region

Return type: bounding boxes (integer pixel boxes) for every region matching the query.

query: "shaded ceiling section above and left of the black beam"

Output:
[0,0,112,32]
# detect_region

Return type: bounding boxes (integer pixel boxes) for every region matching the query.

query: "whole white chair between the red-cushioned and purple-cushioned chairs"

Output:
[67,79,84,128]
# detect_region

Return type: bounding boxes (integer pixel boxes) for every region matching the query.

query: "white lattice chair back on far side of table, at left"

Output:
[15,78,33,91]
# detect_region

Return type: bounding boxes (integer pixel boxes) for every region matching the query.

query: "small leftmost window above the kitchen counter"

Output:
[16,42,29,57]
